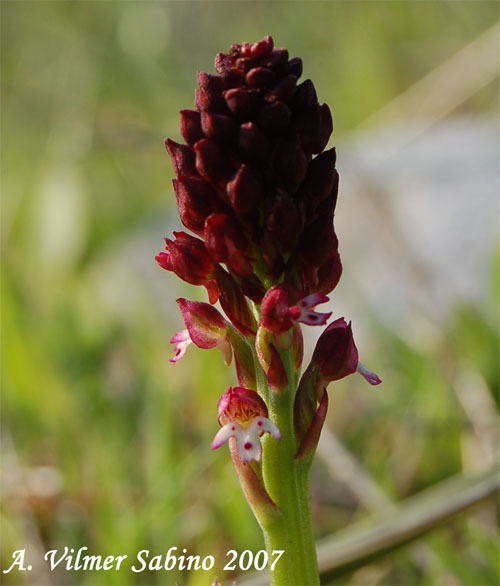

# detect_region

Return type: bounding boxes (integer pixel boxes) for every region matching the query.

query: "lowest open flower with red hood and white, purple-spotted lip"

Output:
[211,387,281,462]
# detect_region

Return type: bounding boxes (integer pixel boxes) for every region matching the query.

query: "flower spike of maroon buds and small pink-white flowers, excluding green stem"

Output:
[156,37,380,461]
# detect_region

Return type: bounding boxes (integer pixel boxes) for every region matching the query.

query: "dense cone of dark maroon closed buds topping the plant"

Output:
[156,36,341,314]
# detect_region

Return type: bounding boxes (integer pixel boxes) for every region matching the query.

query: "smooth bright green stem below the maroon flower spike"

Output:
[257,351,319,586]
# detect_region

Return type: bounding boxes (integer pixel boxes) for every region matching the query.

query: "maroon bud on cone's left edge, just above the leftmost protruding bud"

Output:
[173,177,226,235]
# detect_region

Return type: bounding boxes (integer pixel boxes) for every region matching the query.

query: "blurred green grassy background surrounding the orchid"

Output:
[1,1,499,585]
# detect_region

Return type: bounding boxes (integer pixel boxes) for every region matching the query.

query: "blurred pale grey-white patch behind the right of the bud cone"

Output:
[335,118,499,338]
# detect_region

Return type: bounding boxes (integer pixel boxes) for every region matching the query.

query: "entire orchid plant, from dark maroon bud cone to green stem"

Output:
[156,37,380,585]
